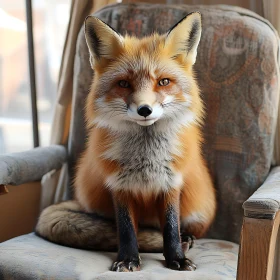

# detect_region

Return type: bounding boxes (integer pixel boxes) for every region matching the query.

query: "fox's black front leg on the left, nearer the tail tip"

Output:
[112,194,140,272]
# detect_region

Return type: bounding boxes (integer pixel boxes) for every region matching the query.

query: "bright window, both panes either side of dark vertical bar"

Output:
[0,0,71,154]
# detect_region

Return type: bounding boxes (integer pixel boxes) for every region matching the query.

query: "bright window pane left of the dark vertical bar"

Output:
[0,0,33,154]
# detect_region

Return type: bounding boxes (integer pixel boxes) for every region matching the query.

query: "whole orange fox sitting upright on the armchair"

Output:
[36,12,216,272]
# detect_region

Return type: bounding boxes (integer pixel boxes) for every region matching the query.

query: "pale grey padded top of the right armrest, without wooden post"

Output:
[243,166,280,219]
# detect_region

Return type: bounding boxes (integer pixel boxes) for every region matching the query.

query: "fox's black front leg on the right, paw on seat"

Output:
[159,190,196,271]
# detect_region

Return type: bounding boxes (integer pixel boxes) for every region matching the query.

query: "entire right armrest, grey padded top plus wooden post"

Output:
[237,167,280,280]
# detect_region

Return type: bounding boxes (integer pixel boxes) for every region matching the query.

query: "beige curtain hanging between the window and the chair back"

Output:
[41,0,116,209]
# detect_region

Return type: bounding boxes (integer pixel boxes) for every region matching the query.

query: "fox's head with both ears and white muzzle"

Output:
[85,12,203,131]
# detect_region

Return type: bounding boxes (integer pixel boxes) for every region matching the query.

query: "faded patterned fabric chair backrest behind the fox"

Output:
[66,4,279,242]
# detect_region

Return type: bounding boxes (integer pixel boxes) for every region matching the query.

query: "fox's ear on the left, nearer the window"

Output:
[84,16,123,67]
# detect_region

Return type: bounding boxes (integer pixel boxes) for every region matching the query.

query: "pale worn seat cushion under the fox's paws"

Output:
[0,233,238,280]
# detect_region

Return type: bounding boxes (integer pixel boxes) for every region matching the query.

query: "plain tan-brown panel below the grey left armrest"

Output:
[0,182,41,242]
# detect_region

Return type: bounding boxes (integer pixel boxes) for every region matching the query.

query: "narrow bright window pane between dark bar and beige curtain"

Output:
[33,0,71,146]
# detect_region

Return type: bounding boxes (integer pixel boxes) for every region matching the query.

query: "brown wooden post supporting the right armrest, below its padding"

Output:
[237,212,280,280]
